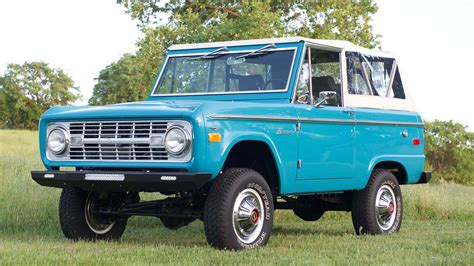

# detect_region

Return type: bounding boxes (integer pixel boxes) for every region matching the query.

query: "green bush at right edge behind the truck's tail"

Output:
[425,120,474,185]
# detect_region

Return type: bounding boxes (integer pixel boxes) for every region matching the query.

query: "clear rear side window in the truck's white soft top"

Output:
[346,52,405,99]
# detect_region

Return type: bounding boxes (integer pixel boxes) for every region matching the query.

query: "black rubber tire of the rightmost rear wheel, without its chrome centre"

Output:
[352,169,403,235]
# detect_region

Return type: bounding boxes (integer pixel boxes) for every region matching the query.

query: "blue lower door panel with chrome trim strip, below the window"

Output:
[297,105,355,180]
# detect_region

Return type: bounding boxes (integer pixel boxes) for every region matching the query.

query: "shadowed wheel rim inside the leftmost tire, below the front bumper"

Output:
[84,192,115,235]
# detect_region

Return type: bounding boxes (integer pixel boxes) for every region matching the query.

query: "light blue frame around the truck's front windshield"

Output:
[149,44,298,97]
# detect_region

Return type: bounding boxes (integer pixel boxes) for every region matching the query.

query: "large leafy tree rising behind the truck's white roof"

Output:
[91,0,379,104]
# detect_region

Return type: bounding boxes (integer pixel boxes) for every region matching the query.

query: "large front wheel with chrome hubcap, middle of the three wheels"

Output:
[204,168,273,250]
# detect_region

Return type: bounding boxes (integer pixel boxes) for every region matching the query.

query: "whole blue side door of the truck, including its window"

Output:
[296,48,355,180]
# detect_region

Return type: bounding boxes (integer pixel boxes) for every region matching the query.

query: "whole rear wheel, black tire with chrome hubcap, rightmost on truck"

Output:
[352,169,403,235]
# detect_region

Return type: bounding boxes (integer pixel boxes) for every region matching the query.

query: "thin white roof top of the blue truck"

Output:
[168,36,392,57]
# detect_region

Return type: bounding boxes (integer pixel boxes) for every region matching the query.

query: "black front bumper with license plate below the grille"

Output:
[31,171,212,192]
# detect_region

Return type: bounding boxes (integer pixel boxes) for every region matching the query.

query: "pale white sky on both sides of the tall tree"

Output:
[0,0,474,131]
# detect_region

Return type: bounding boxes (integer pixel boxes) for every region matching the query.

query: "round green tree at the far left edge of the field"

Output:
[0,62,80,129]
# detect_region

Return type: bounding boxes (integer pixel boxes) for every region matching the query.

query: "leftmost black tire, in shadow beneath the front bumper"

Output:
[59,187,127,240]
